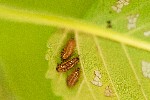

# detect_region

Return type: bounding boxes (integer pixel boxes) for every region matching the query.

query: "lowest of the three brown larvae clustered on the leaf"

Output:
[67,68,80,87]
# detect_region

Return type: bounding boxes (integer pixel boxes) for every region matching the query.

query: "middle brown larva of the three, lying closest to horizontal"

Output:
[56,57,79,72]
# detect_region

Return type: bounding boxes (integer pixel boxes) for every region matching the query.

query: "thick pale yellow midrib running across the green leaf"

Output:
[0,5,150,51]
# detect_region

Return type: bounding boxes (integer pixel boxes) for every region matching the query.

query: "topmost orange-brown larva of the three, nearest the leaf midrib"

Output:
[61,39,76,59]
